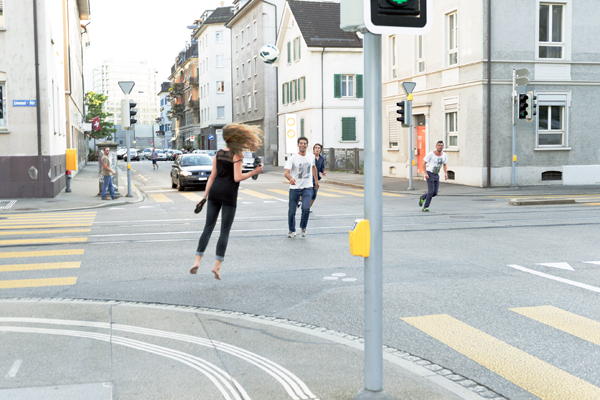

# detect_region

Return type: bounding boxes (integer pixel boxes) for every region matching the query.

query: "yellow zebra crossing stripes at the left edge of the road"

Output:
[0,211,96,290]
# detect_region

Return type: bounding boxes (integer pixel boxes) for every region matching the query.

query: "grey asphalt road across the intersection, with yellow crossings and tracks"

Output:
[0,158,600,399]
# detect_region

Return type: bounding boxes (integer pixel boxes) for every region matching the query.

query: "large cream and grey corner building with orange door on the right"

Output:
[382,0,600,186]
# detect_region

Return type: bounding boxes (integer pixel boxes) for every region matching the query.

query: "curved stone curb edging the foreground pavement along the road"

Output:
[0,297,507,400]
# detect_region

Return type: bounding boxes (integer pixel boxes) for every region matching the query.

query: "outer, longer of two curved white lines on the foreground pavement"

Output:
[0,318,318,400]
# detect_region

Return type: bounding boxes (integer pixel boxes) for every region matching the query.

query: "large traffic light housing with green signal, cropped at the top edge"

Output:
[364,0,432,35]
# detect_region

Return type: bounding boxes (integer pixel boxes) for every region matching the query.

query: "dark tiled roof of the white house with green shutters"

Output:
[288,0,362,48]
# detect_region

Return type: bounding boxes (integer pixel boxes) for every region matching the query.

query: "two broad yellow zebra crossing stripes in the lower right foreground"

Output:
[402,306,600,400]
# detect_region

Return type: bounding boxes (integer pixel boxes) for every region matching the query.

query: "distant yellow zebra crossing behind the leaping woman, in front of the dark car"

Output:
[148,185,404,204]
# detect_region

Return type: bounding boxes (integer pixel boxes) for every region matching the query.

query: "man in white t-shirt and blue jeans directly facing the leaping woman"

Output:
[284,137,319,238]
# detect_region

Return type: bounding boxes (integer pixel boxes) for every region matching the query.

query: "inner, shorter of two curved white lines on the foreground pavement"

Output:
[0,326,246,400]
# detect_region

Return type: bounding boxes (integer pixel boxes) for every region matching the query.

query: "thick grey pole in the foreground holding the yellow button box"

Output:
[355,32,392,400]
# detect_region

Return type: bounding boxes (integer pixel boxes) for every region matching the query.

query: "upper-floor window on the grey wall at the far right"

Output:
[538,3,565,58]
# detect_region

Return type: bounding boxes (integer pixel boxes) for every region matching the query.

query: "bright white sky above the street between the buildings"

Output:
[82,0,232,91]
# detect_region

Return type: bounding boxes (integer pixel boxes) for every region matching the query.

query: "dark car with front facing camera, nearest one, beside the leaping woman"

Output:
[171,154,212,191]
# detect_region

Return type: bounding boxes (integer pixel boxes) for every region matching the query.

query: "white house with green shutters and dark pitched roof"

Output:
[277,1,364,165]
